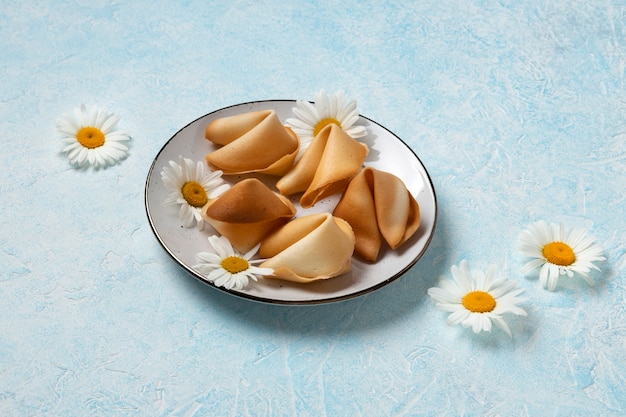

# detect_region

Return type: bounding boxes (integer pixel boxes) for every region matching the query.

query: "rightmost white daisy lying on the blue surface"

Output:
[519,220,606,291]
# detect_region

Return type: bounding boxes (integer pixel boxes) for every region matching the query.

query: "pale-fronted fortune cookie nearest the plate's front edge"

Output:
[259,213,355,283]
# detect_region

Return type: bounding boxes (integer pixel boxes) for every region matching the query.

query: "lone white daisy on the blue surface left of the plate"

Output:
[56,104,130,168]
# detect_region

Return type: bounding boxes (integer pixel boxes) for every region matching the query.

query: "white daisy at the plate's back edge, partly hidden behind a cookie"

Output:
[286,90,367,159]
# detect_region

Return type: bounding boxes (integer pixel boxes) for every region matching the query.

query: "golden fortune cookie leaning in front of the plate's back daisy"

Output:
[276,123,369,208]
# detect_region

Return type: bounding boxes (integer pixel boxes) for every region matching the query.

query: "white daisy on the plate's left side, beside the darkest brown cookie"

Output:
[161,156,229,230]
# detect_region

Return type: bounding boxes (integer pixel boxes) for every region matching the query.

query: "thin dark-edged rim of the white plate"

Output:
[144,99,439,306]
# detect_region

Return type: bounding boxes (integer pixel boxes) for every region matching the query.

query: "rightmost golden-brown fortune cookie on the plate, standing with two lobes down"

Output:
[333,167,420,262]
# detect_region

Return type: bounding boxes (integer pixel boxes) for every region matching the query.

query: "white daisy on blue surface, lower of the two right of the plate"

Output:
[428,260,526,337]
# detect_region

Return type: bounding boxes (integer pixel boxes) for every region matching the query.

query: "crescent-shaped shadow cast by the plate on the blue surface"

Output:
[178,203,451,337]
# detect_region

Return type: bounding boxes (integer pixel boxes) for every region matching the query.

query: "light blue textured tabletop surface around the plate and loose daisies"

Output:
[0,0,626,417]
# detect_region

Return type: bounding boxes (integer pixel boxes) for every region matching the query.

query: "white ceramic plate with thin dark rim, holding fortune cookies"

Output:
[145,100,437,305]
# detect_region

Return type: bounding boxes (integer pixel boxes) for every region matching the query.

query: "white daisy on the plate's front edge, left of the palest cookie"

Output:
[194,236,274,290]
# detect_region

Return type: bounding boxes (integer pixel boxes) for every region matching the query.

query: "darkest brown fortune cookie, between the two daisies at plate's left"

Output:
[201,178,296,253]
